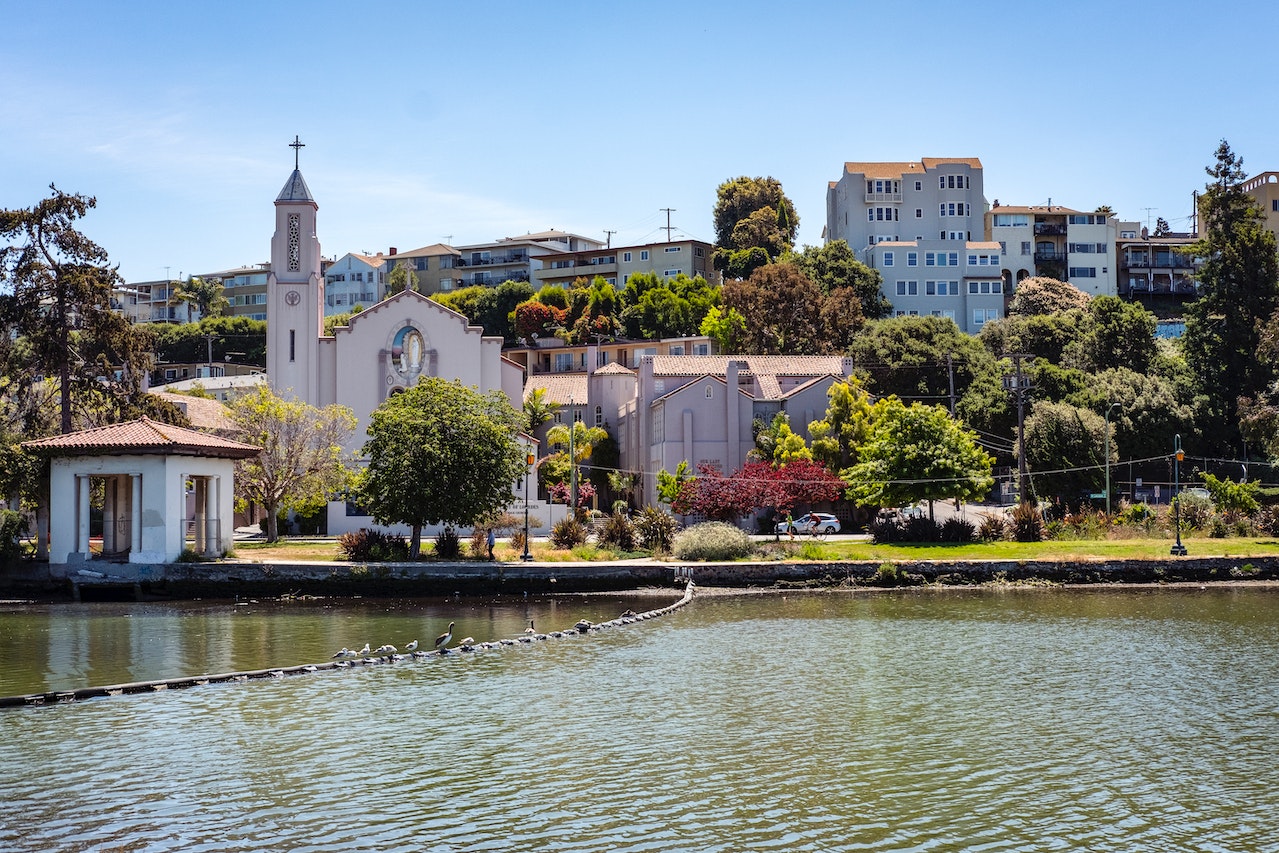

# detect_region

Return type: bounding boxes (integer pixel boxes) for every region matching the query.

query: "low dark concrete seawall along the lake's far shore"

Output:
[9,556,1279,600]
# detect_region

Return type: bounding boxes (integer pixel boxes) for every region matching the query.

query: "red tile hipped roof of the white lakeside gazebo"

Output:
[22,418,262,459]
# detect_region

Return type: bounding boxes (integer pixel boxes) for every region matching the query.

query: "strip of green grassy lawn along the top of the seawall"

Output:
[235,537,1279,563]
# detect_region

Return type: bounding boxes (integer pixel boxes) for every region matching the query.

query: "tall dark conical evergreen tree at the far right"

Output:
[1182,139,1279,451]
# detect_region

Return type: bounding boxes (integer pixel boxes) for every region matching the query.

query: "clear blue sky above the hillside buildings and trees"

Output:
[0,0,1279,281]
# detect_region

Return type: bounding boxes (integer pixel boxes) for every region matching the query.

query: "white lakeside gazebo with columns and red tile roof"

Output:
[22,417,261,567]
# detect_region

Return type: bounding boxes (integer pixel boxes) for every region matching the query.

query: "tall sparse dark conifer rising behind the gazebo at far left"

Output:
[0,184,153,434]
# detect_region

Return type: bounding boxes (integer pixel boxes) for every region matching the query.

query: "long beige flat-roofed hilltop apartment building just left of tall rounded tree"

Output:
[533,239,721,288]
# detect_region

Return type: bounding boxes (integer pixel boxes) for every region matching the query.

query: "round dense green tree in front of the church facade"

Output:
[359,376,526,559]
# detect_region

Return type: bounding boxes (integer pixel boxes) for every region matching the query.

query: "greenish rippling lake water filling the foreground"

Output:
[0,587,1279,853]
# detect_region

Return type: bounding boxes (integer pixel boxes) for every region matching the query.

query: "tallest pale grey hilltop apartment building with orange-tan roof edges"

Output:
[824,157,1004,333]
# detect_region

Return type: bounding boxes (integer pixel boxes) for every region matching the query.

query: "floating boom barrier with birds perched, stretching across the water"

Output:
[0,579,693,707]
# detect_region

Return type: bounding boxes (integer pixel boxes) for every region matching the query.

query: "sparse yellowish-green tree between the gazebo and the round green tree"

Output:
[229,385,356,542]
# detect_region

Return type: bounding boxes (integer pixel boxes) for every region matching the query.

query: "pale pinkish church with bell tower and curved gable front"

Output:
[266,155,544,535]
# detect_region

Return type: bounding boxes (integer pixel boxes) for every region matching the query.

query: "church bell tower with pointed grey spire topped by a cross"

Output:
[266,137,324,405]
